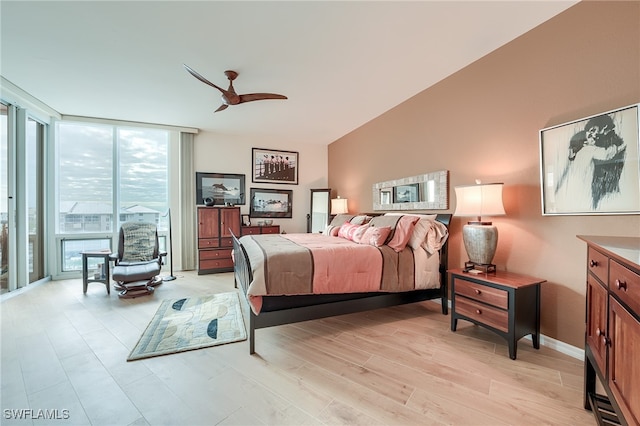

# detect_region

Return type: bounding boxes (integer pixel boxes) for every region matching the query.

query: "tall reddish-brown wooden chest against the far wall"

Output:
[198,207,240,275]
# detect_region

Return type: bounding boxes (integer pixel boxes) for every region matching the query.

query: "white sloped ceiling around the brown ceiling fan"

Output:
[0,0,577,144]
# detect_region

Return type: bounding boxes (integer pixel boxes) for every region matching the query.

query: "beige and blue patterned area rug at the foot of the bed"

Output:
[127,292,247,361]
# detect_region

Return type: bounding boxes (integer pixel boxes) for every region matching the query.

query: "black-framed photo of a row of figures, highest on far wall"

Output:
[251,148,298,185]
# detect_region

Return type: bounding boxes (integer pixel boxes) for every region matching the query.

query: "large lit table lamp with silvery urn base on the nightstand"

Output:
[454,181,505,272]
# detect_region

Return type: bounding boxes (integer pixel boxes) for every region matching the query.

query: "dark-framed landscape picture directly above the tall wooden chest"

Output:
[196,172,245,206]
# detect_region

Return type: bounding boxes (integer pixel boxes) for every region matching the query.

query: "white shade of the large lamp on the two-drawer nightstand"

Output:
[454,183,505,217]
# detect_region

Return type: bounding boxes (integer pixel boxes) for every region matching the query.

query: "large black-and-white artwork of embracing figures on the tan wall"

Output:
[540,104,640,215]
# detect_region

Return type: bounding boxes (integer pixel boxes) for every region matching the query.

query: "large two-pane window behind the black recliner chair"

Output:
[55,121,170,274]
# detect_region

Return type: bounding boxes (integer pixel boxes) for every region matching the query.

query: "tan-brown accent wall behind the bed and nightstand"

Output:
[329,1,640,348]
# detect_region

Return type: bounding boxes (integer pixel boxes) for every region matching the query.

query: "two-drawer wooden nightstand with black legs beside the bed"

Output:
[448,269,546,359]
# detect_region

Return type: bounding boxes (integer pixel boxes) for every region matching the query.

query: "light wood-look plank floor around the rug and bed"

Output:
[0,272,595,425]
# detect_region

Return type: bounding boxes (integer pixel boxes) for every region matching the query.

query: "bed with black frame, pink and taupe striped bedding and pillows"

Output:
[233,213,451,354]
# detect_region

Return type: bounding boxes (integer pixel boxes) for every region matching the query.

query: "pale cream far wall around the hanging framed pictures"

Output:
[194,132,327,233]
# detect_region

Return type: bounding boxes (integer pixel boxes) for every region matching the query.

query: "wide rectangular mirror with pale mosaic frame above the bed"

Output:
[373,170,449,211]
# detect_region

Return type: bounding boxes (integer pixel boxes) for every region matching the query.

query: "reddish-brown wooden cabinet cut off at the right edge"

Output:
[578,235,640,425]
